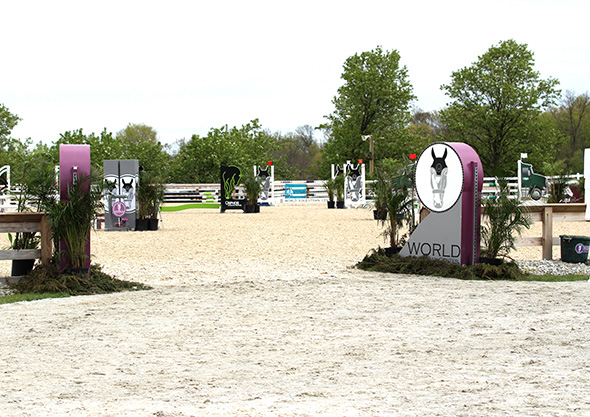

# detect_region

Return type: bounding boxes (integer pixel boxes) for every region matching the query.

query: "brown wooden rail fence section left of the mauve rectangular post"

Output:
[0,213,53,264]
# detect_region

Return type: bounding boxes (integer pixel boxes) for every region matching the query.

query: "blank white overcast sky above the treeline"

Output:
[0,0,590,143]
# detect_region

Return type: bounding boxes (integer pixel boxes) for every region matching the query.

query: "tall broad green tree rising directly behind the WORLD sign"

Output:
[441,40,560,176]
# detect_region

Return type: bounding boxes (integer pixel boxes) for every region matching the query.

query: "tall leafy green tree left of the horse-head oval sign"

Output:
[321,46,415,169]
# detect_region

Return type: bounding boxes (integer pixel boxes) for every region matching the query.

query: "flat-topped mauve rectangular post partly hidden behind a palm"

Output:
[59,145,90,271]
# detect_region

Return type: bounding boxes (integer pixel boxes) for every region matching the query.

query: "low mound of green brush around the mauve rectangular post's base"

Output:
[11,263,152,295]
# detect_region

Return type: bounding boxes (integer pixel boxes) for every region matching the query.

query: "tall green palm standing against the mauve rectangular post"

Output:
[47,174,103,272]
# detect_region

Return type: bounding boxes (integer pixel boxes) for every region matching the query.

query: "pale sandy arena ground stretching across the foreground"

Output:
[0,204,590,417]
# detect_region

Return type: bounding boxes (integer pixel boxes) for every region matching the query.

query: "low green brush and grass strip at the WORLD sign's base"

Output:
[356,248,588,282]
